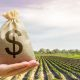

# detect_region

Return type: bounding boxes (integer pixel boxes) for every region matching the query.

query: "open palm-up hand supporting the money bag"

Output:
[0,60,39,77]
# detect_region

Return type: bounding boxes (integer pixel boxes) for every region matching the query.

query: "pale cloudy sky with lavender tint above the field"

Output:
[0,0,80,50]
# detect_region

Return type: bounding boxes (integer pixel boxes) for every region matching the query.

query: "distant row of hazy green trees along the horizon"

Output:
[34,48,80,54]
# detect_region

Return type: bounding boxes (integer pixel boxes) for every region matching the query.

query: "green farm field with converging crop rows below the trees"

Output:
[2,48,80,80]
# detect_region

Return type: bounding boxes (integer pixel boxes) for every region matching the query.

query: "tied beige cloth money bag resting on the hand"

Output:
[0,10,35,64]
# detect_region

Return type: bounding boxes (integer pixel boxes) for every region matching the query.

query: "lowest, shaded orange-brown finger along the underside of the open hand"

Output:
[8,63,36,76]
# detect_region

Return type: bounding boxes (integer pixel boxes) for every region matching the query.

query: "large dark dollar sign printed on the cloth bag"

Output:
[5,30,23,58]
